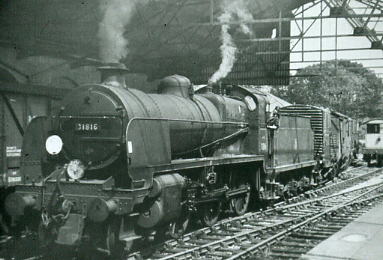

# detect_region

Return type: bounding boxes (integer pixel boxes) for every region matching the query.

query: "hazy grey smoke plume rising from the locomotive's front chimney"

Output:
[98,0,143,62]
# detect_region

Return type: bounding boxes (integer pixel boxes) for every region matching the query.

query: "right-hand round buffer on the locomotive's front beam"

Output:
[88,198,118,222]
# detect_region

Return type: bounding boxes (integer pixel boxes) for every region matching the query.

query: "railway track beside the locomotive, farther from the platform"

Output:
[139,167,383,260]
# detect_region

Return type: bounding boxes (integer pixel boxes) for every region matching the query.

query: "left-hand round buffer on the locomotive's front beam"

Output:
[5,193,36,217]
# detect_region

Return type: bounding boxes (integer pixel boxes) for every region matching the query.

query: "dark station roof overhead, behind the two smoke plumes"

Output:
[0,0,312,85]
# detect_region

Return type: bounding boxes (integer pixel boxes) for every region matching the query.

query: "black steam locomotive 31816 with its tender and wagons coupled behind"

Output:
[5,64,353,255]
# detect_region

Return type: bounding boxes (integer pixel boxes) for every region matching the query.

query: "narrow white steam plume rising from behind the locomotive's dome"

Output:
[209,0,254,83]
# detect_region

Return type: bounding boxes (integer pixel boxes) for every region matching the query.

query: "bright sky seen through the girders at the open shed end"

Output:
[290,0,383,78]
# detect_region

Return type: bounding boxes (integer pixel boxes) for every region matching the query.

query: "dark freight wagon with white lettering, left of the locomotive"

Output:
[0,81,64,187]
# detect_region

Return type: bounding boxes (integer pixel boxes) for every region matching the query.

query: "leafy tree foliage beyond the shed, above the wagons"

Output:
[272,60,383,118]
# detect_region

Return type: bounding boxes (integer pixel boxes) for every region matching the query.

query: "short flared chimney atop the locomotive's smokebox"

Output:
[98,63,129,88]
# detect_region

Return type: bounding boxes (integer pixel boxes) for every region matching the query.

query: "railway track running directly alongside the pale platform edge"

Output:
[236,195,383,260]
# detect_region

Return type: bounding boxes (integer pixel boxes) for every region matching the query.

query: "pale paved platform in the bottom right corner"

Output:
[301,203,383,260]
